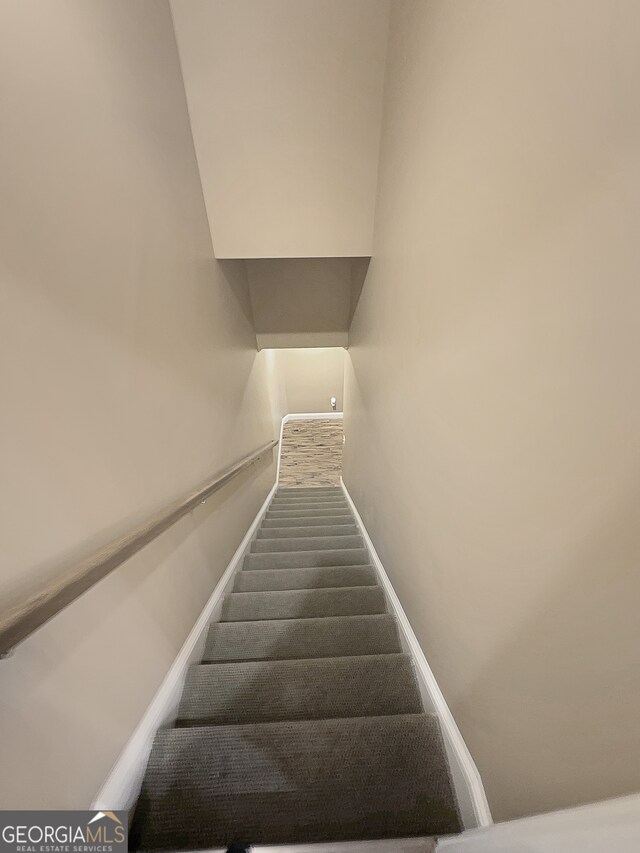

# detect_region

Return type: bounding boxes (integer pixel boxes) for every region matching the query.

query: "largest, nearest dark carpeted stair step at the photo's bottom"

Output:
[131,714,461,850]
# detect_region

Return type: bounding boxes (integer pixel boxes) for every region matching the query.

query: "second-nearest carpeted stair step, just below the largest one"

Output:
[178,654,422,725]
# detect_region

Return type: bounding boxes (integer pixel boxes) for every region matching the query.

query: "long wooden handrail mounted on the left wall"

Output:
[0,439,278,657]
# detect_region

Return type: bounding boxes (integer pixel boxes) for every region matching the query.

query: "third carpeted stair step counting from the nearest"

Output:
[203,613,401,661]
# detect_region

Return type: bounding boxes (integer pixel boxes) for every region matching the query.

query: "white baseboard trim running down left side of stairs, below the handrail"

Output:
[91,482,278,811]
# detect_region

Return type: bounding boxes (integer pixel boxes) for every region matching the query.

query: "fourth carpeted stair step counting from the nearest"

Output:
[221,587,385,622]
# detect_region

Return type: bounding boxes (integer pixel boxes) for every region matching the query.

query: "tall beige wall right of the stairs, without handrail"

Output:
[344,0,640,819]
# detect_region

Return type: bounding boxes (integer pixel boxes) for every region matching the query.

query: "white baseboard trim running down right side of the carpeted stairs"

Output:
[340,477,493,829]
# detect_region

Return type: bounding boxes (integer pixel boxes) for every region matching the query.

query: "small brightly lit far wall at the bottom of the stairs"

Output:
[265,347,346,415]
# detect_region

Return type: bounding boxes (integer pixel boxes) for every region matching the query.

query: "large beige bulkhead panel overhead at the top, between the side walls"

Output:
[171,0,389,258]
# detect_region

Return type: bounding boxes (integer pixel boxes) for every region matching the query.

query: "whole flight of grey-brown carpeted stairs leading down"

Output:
[131,488,461,850]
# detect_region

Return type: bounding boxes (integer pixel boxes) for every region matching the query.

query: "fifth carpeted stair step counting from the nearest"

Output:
[233,566,377,592]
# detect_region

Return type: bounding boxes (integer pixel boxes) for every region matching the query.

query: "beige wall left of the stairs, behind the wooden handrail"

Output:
[0,0,277,808]
